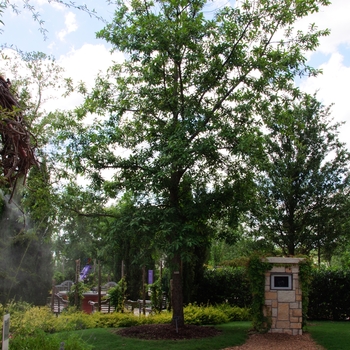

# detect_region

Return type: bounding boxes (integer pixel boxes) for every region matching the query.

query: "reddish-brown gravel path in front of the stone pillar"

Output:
[223,333,325,350]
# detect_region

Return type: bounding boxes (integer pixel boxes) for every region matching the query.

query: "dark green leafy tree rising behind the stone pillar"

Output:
[252,95,350,255]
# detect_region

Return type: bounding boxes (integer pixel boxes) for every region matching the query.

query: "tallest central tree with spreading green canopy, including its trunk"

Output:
[54,0,329,326]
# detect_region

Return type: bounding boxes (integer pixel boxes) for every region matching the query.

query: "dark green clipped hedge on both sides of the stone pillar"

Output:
[196,267,350,321]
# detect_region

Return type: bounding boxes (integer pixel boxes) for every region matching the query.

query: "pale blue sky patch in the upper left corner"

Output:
[1,0,113,54]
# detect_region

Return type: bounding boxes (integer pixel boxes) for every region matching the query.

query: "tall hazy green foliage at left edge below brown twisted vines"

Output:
[0,166,53,305]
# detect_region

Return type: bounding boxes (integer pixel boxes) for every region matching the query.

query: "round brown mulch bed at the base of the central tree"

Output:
[116,324,221,340]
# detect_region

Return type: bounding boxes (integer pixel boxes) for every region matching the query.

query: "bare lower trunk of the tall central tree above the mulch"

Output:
[171,256,185,328]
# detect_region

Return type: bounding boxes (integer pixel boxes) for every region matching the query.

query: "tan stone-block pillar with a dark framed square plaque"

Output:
[264,257,303,335]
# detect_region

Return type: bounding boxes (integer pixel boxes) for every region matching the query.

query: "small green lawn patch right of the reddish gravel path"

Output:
[307,321,350,350]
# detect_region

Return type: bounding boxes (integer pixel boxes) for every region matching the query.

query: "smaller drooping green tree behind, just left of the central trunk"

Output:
[98,193,157,300]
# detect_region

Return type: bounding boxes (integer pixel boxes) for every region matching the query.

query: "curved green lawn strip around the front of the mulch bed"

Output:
[71,322,251,350]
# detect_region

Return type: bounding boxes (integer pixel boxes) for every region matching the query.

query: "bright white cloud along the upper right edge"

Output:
[300,0,350,149]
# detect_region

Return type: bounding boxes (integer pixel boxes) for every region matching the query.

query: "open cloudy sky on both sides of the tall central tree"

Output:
[0,0,350,148]
